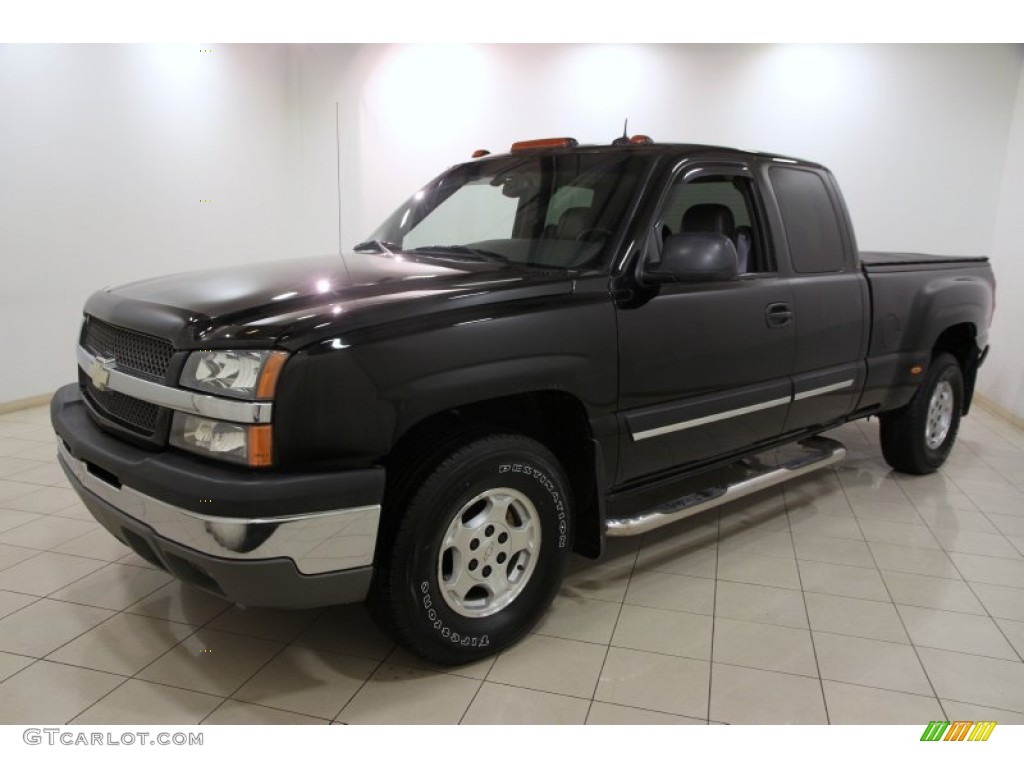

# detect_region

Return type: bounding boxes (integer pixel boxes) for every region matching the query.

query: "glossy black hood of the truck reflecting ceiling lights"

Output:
[85,253,572,349]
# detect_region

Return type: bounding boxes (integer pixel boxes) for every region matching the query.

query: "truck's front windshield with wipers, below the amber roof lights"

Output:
[356,150,650,269]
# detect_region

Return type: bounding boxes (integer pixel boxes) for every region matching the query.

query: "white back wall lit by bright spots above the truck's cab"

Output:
[306,45,1022,259]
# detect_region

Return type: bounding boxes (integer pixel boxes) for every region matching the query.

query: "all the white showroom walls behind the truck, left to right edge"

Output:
[6,45,1024,423]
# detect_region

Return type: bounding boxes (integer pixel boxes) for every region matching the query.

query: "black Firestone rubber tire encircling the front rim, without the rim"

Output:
[396,437,571,660]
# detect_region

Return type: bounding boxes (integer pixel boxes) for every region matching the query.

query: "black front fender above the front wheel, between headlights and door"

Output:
[274,292,617,465]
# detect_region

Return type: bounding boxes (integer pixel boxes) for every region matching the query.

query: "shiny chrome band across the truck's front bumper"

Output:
[57,439,381,575]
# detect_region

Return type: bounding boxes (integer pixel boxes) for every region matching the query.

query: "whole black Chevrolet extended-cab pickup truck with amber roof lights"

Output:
[51,136,994,664]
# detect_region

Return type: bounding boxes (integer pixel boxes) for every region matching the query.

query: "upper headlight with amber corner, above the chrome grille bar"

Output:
[179,349,288,400]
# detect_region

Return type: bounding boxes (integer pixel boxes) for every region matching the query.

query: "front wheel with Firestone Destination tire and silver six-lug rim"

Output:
[370,434,572,666]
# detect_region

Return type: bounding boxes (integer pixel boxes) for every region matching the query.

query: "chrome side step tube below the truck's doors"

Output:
[604,436,846,537]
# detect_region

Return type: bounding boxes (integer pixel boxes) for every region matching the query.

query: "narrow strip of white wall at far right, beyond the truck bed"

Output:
[979,64,1024,419]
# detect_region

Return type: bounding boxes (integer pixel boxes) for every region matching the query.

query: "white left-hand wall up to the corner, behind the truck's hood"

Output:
[0,45,300,402]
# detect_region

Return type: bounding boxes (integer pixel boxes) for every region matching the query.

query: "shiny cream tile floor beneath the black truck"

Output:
[0,409,1024,725]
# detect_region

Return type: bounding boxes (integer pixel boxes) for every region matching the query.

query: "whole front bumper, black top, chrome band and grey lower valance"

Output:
[50,385,384,607]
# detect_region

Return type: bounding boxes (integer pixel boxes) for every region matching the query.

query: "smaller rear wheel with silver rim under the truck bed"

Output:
[880,353,964,475]
